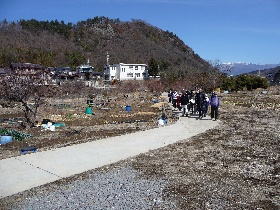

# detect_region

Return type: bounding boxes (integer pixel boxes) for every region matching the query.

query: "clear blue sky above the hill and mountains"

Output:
[0,0,280,65]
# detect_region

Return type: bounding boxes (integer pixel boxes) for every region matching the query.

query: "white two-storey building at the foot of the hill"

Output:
[104,63,149,81]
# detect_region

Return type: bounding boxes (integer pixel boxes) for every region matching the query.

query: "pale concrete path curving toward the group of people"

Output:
[0,99,218,198]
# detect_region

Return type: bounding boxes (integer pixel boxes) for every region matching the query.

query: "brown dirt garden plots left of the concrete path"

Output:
[0,92,176,159]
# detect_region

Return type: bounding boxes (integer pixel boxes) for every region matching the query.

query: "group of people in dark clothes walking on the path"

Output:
[168,88,220,120]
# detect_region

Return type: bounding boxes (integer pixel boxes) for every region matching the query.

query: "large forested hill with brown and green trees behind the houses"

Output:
[0,17,209,74]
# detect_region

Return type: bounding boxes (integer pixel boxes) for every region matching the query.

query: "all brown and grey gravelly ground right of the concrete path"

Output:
[0,91,280,209]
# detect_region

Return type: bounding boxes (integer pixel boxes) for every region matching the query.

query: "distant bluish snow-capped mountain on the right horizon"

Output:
[222,62,280,75]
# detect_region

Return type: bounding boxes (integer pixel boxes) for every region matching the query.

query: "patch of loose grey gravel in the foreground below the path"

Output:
[2,167,175,209]
